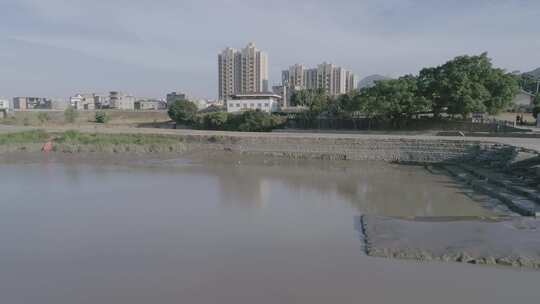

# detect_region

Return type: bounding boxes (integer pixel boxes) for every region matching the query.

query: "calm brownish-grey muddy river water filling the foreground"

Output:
[0,159,540,304]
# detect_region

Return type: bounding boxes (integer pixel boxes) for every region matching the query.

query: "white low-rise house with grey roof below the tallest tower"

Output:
[227,93,281,113]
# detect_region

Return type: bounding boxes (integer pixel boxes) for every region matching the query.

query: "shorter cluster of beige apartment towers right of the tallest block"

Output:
[282,62,358,95]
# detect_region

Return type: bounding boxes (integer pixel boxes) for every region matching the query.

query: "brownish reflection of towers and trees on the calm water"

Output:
[199,162,492,216]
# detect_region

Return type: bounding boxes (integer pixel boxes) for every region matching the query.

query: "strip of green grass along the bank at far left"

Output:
[0,130,178,146]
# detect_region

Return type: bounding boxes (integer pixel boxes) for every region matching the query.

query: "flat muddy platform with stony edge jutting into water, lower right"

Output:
[358,215,540,269]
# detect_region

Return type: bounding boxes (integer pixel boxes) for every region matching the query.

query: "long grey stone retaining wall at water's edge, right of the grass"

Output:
[181,135,505,163]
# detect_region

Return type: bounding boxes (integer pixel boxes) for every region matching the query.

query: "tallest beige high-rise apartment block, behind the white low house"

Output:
[218,43,268,100]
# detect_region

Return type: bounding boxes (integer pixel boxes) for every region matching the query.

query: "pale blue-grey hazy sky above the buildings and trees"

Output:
[0,0,540,98]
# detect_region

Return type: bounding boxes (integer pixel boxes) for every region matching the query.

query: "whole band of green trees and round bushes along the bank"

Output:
[169,53,540,131]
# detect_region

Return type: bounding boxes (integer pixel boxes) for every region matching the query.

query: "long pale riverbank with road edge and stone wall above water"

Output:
[0,126,540,163]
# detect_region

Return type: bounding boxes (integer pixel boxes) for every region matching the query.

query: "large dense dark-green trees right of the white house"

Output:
[291,53,519,120]
